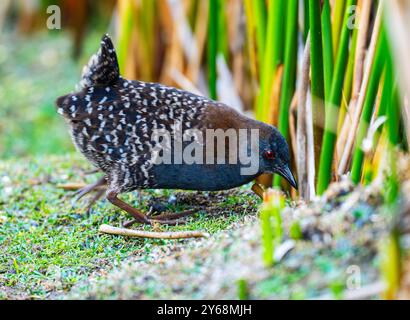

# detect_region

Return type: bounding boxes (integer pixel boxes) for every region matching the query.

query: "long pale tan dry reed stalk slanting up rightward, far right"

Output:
[337,5,382,176]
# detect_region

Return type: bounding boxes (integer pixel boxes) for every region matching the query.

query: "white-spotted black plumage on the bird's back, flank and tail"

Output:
[58,34,213,190]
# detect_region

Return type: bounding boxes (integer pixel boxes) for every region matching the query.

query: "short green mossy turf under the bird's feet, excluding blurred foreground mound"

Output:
[0,156,258,298]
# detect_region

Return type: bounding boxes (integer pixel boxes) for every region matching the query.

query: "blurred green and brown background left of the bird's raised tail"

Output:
[0,0,115,159]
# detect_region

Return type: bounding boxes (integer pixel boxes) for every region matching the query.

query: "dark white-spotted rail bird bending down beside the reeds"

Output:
[56,35,297,223]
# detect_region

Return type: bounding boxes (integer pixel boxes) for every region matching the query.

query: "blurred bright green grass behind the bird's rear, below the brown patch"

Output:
[0,31,80,158]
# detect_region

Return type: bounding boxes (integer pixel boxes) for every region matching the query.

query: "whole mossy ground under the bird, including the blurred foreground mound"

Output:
[0,155,387,299]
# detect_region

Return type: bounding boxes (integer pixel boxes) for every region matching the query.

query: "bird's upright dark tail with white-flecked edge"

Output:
[80,34,120,88]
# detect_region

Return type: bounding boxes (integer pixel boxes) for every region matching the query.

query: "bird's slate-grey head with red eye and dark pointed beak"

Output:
[259,126,298,189]
